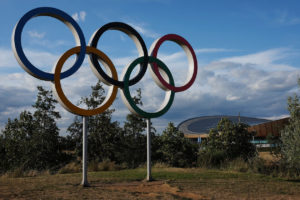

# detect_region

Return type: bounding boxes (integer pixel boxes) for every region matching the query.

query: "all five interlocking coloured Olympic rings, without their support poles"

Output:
[11,7,198,118]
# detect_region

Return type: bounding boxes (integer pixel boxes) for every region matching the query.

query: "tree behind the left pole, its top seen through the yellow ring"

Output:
[67,81,121,162]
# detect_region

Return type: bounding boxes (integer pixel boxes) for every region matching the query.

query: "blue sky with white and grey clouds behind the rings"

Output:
[0,0,300,134]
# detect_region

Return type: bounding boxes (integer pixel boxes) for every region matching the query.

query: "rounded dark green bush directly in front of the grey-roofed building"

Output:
[199,118,256,166]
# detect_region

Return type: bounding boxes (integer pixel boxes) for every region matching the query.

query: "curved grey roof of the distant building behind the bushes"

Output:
[178,115,270,136]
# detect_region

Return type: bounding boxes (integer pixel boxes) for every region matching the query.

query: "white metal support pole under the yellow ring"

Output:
[81,116,89,187]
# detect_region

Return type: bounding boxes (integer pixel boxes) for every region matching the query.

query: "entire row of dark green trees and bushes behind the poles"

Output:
[0,79,300,176]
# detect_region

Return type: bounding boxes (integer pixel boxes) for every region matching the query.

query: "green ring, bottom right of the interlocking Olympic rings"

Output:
[122,56,175,119]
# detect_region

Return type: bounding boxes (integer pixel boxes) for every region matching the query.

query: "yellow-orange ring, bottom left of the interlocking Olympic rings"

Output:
[53,46,118,116]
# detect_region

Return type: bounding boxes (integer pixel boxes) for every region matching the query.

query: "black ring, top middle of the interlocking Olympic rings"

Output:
[89,22,149,88]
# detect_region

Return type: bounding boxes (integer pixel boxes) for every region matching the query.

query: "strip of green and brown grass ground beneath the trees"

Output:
[0,168,300,199]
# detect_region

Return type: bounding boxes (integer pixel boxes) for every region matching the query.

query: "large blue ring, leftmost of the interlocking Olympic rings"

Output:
[12,7,86,81]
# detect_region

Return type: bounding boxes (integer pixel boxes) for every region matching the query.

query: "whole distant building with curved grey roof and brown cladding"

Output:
[178,115,289,144]
